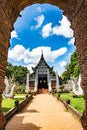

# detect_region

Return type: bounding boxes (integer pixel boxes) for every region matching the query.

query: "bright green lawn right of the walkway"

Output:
[60,93,85,113]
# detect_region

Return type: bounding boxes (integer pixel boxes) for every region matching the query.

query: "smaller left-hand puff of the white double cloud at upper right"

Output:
[42,23,53,38]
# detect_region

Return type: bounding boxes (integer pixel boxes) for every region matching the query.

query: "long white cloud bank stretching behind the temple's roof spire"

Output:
[8,45,67,72]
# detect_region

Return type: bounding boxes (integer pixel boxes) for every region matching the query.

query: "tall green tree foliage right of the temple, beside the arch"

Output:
[61,51,80,83]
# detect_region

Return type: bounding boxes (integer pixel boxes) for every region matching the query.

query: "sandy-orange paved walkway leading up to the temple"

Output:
[5,94,83,130]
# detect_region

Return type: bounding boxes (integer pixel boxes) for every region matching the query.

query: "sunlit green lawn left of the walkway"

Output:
[2,94,24,114]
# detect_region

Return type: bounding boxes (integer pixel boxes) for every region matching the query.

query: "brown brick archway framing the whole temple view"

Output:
[0,0,87,130]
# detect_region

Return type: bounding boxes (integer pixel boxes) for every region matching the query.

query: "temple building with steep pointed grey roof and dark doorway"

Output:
[29,53,58,93]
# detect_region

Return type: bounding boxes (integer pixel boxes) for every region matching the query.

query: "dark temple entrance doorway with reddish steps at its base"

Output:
[38,74,48,93]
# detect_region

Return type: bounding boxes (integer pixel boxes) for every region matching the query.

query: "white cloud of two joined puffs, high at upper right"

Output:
[42,15,73,38]
